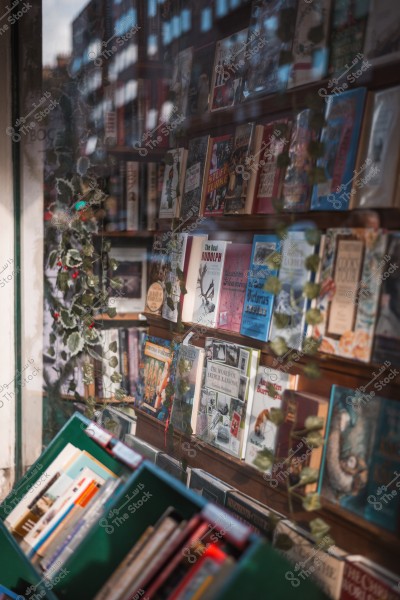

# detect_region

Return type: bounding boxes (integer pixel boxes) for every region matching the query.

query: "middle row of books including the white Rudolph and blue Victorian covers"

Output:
[146,230,400,364]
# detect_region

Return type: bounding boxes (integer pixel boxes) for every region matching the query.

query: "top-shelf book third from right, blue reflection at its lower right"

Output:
[288,0,333,88]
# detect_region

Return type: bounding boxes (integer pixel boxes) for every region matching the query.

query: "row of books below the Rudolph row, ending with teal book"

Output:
[138,337,400,530]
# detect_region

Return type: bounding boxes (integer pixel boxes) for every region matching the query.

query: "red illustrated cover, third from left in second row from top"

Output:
[202,134,233,217]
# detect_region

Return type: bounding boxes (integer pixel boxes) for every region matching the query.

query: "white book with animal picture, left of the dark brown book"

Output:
[245,365,297,473]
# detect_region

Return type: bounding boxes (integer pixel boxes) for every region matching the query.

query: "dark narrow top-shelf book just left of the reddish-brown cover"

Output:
[187,43,215,117]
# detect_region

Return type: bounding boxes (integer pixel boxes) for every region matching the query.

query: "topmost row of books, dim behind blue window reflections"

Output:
[170,0,400,115]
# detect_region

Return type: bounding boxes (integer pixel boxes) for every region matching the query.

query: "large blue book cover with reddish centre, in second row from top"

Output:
[311,87,366,210]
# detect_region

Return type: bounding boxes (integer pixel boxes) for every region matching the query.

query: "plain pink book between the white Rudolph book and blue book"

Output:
[217,243,252,333]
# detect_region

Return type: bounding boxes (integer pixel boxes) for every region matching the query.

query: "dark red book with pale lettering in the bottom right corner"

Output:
[340,555,400,600]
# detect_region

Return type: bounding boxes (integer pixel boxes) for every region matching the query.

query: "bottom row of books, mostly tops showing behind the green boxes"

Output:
[120,436,400,600]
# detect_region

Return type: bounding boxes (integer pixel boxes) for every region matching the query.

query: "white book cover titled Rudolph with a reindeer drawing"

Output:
[191,240,230,327]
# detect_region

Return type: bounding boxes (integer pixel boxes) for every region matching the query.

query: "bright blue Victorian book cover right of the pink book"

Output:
[240,235,280,342]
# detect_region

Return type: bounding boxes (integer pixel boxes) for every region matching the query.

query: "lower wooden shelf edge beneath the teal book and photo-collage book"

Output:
[136,410,400,572]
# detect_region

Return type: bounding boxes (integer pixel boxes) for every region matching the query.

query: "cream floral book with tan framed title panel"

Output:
[311,228,387,362]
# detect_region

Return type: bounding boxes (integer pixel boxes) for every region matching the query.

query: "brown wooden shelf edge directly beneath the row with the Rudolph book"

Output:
[147,314,400,401]
